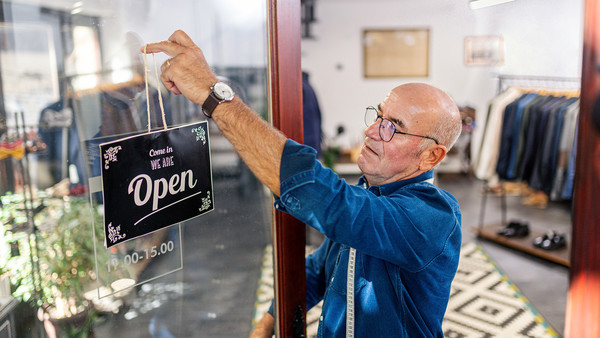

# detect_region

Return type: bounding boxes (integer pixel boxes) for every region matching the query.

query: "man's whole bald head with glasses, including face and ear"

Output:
[357,83,461,185]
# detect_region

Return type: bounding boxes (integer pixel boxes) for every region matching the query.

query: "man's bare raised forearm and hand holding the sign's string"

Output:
[142,30,287,196]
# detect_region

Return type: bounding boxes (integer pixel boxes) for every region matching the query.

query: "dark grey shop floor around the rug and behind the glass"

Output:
[81,175,570,337]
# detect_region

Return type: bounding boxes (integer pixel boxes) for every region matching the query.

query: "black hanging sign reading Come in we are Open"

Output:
[100,121,214,248]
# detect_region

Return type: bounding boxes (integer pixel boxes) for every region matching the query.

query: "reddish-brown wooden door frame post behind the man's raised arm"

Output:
[268,0,306,337]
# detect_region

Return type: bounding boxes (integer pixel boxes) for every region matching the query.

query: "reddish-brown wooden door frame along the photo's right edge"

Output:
[565,0,600,337]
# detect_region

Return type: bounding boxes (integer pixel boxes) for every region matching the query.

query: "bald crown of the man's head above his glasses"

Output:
[382,83,462,149]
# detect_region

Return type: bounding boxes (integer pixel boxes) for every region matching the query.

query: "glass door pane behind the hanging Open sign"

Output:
[0,0,290,337]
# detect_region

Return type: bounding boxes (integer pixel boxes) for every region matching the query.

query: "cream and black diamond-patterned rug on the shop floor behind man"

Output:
[253,243,560,338]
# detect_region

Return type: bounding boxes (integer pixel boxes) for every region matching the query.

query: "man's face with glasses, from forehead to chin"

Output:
[358,87,435,185]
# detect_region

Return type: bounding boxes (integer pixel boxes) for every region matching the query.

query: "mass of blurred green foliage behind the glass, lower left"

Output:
[0,195,123,337]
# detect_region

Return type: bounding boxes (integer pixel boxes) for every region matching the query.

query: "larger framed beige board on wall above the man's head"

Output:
[363,29,429,78]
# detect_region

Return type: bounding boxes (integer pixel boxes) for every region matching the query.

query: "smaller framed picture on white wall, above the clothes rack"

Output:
[465,36,504,66]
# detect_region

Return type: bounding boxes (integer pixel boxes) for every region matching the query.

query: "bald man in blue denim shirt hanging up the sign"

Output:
[147,31,461,337]
